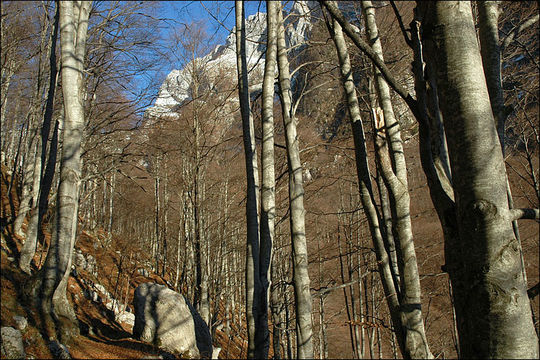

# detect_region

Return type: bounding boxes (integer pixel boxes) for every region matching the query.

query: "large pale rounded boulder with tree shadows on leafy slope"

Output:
[133,283,212,358]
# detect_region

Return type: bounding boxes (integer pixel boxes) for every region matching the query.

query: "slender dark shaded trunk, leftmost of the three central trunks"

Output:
[235,0,266,359]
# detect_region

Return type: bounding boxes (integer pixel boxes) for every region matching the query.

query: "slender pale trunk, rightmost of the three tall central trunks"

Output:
[277,3,313,359]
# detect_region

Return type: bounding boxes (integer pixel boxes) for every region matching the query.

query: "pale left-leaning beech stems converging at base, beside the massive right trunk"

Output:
[326,1,432,358]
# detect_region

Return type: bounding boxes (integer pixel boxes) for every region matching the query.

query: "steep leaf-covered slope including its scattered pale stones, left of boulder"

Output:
[0,166,246,359]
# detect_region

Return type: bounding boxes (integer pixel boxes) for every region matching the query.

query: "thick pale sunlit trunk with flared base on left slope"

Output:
[24,1,91,341]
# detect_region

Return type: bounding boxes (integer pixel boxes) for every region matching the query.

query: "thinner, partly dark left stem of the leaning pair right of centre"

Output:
[322,10,404,358]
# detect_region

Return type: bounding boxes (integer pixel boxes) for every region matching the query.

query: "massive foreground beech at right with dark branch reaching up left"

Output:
[324,2,538,357]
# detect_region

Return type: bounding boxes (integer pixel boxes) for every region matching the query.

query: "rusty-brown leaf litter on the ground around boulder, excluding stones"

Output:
[0,167,246,359]
